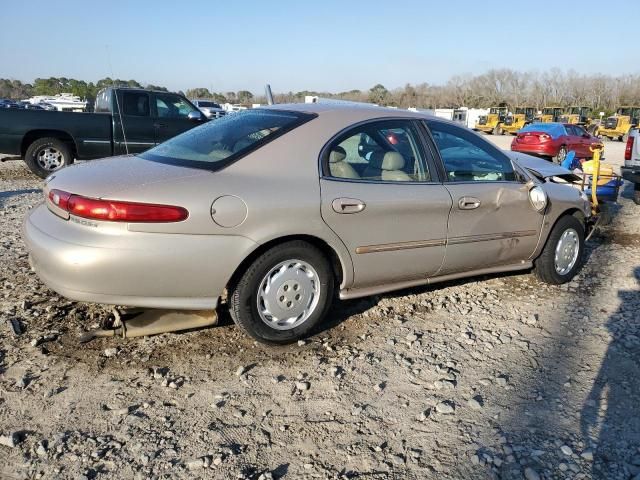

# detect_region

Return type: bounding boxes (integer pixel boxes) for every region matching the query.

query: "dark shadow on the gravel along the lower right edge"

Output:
[580,267,640,478]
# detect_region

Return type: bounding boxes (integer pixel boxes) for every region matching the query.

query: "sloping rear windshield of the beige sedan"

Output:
[139,109,315,170]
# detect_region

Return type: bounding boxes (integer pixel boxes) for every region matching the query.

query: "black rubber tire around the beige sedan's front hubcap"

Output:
[533,215,584,285]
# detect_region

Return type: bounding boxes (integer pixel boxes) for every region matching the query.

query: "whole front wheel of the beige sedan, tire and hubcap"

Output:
[534,215,584,285]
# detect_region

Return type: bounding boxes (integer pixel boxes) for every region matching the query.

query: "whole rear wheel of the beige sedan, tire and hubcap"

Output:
[229,240,334,344]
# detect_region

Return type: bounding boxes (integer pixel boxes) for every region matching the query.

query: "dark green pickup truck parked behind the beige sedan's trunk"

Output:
[0,88,207,178]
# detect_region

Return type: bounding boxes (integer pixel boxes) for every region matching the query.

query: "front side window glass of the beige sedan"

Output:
[427,121,516,182]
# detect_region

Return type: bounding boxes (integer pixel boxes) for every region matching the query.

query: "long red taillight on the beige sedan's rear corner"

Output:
[49,189,189,223]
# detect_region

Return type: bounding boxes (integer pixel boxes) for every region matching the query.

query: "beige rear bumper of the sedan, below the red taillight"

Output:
[22,205,255,310]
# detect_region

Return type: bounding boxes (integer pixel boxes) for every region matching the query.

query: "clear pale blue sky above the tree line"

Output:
[0,0,640,93]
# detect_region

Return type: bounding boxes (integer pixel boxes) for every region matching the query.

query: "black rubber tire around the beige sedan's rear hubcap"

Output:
[229,240,334,345]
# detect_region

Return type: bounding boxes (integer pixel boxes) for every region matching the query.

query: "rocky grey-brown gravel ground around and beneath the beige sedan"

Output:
[0,137,640,480]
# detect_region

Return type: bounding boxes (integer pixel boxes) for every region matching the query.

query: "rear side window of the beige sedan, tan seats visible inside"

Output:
[325,120,432,182]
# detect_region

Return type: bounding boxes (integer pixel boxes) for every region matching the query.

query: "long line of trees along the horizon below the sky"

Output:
[5,69,640,113]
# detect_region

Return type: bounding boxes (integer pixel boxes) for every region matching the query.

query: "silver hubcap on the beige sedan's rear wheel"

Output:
[257,260,320,330]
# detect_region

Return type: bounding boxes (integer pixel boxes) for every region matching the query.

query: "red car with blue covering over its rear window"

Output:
[511,122,602,163]
